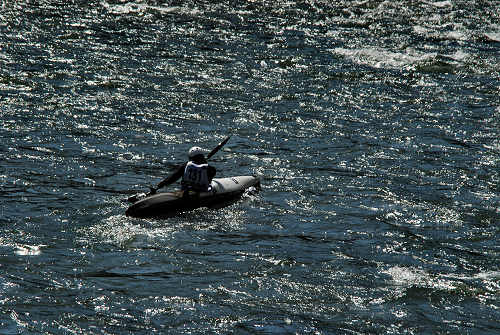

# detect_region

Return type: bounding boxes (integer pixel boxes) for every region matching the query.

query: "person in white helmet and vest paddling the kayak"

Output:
[151,147,216,193]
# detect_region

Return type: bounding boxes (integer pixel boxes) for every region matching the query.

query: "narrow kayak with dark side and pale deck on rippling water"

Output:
[125,176,260,218]
